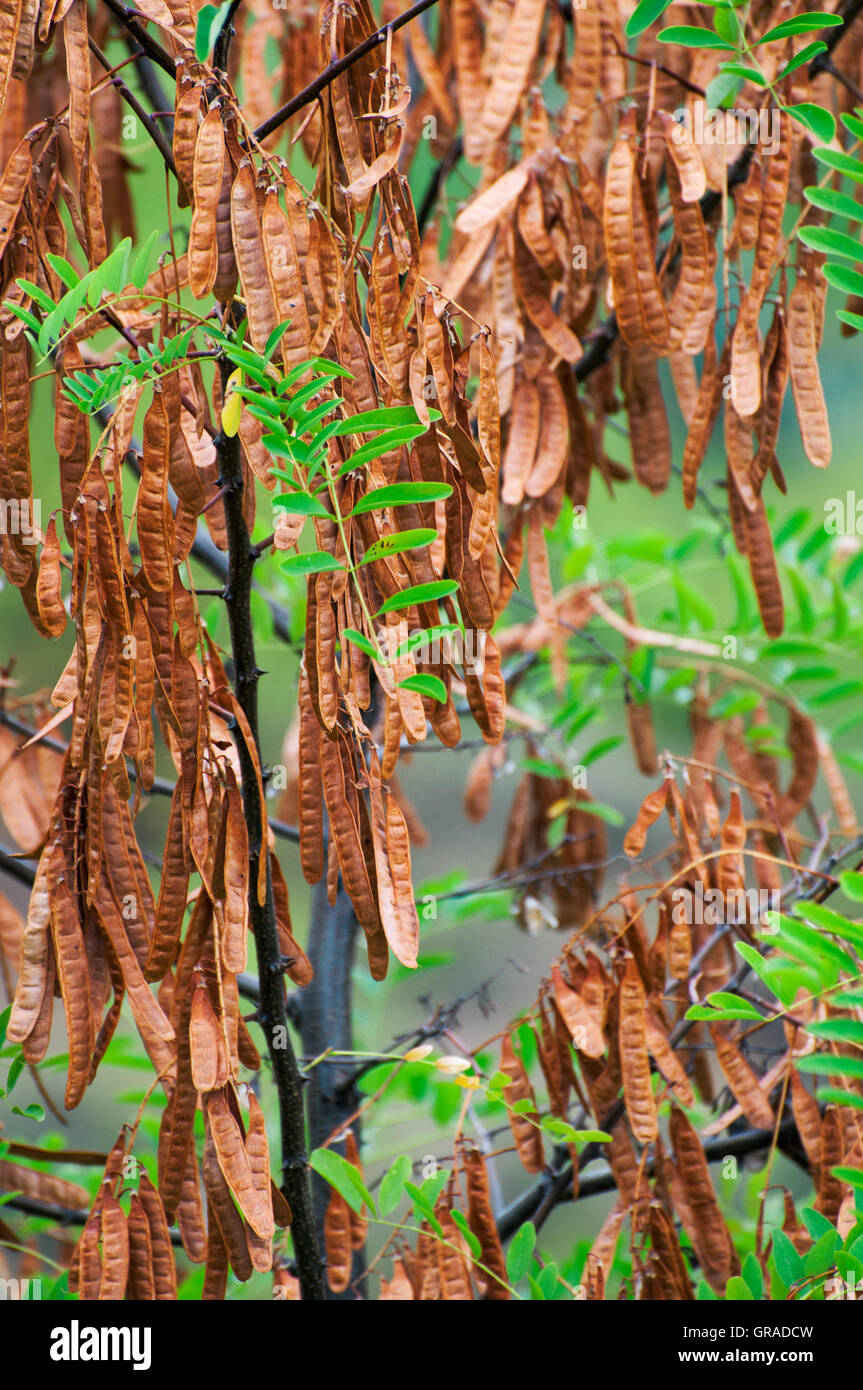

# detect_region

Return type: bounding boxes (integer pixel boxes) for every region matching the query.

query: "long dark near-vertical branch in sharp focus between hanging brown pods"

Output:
[215,359,325,1301]
